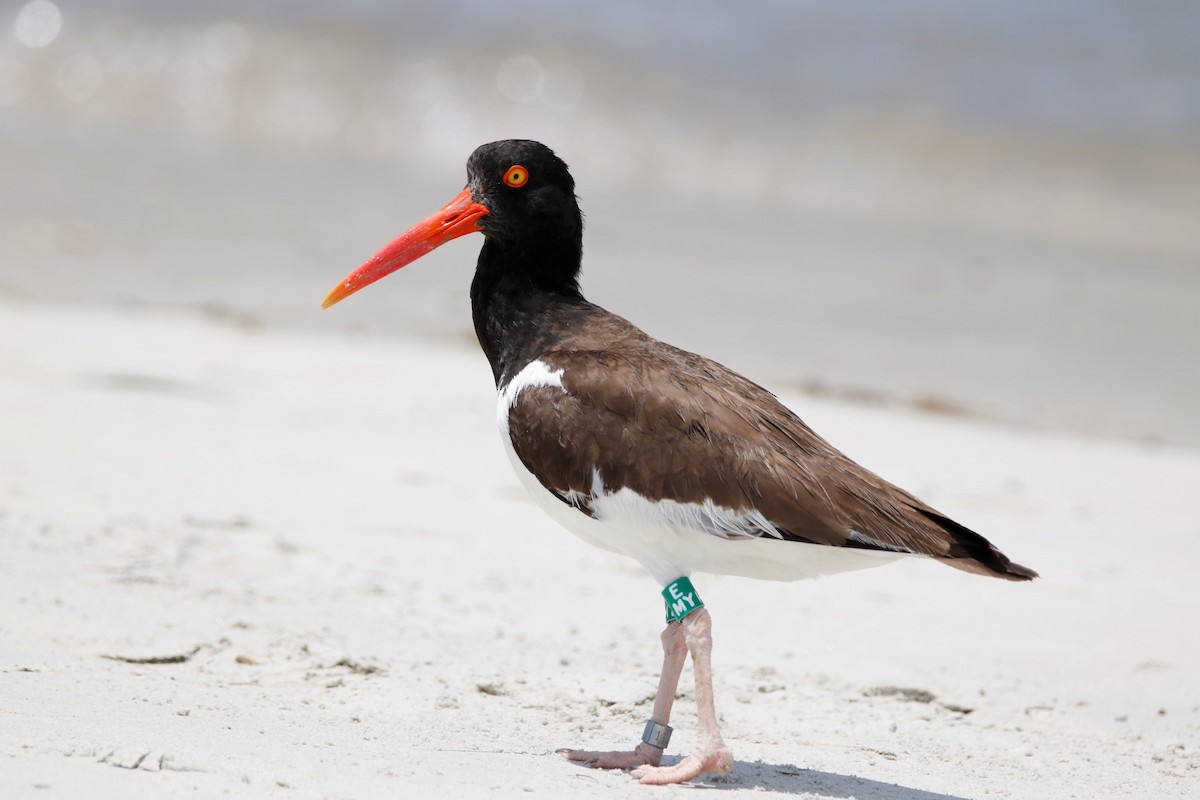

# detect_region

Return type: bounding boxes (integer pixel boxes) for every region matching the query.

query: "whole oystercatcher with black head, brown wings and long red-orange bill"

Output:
[324,140,1037,783]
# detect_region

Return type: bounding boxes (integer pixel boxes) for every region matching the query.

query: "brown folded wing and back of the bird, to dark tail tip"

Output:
[509,321,1036,581]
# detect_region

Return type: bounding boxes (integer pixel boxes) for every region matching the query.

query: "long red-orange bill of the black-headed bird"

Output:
[320,188,487,308]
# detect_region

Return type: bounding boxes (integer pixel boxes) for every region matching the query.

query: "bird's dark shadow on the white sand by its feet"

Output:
[664,759,966,800]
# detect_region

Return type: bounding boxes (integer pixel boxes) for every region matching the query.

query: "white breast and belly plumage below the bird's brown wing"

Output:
[497,361,901,585]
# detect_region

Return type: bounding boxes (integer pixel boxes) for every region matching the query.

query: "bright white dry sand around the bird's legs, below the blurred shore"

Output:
[0,305,1200,800]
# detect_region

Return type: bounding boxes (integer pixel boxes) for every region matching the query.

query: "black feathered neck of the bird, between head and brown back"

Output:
[470,239,592,386]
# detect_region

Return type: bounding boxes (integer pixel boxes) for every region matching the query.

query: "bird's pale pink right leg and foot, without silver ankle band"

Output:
[634,607,733,784]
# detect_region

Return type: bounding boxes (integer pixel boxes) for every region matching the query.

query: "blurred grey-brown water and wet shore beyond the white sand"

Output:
[0,0,1200,445]
